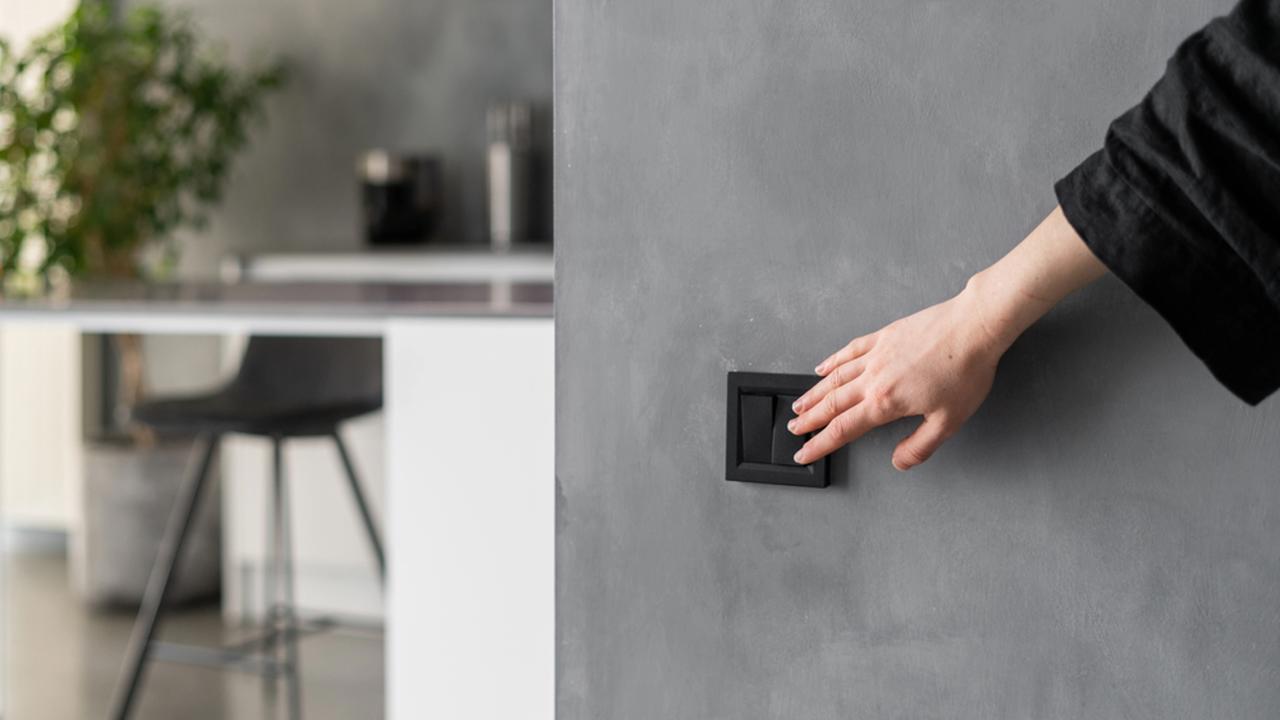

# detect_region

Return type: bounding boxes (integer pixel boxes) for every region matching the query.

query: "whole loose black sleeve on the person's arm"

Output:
[1055,0,1280,404]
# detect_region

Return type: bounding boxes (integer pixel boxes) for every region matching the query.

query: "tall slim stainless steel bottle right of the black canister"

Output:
[485,102,532,251]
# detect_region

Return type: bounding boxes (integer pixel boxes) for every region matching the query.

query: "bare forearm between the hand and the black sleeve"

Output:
[961,208,1106,354]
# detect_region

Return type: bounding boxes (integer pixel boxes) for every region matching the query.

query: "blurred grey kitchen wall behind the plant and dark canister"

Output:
[138,0,552,273]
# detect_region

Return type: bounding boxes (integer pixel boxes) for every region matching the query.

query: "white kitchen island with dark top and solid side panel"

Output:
[0,281,554,719]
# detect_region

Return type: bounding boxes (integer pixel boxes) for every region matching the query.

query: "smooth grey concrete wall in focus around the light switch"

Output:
[556,0,1280,720]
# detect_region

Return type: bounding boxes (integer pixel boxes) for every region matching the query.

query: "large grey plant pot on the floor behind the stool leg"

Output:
[70,438,221,606]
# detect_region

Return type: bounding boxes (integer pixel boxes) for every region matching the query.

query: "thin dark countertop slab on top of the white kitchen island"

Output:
[0,282,553,319]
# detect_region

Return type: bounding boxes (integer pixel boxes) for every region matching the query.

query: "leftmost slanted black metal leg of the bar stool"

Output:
[110,434,220,720]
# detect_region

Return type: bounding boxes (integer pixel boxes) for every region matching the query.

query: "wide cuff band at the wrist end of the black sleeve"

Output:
[1055,150,1280,405]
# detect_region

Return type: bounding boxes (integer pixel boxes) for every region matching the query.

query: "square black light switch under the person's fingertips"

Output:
[724,373,827,488]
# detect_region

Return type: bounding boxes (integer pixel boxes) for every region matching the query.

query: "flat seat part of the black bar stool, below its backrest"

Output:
[133,391,383,437]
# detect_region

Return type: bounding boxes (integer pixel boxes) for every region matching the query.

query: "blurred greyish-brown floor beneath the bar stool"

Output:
[4,552,383,720]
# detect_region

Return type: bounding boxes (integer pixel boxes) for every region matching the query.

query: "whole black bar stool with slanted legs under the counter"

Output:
[110,336,387,720]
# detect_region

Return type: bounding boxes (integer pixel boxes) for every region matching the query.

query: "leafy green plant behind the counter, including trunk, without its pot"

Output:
[0,0,284,599]
